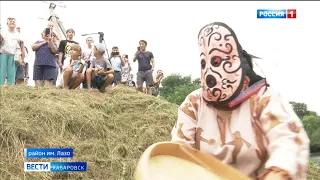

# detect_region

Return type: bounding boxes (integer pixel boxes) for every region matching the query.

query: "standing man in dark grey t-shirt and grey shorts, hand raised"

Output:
[133,40,155,95]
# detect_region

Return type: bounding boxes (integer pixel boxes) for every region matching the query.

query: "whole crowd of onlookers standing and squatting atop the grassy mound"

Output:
[0,17,163,96]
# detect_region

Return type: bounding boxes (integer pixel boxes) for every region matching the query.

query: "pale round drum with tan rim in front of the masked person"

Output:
[135,142,250,180]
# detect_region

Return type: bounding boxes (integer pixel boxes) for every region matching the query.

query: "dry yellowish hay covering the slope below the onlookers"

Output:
[0,86,320,180]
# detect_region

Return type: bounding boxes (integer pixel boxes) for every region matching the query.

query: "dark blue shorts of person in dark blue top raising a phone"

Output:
[33,65,57,81]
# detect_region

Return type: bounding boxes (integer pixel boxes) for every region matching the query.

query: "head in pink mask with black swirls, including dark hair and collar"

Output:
[198,22,266,109]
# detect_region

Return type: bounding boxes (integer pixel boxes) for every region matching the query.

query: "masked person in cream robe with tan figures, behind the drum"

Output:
[172,22,310,180]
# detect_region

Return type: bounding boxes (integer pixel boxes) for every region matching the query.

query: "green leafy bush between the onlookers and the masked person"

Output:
[160,74,200,105]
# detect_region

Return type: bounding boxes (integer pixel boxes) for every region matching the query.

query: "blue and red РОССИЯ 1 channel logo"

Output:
[257,9,297,19]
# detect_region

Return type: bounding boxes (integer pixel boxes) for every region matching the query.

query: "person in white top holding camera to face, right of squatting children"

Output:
[109,46,125,85]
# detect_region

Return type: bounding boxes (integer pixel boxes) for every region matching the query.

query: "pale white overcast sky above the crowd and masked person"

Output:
[0,1,320,113]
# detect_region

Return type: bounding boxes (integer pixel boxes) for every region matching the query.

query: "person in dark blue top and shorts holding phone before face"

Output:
[32,31,58,86]
